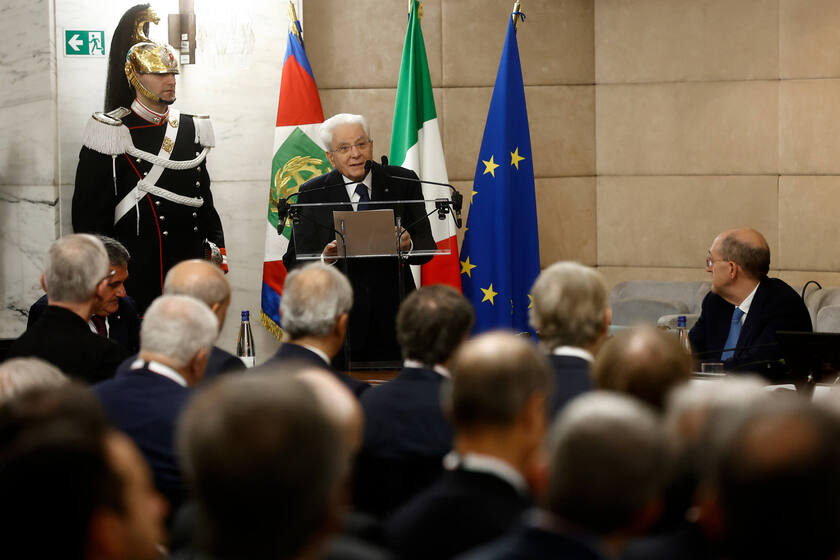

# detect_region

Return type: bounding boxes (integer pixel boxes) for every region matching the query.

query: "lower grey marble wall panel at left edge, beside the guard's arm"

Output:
[0,185,58,338]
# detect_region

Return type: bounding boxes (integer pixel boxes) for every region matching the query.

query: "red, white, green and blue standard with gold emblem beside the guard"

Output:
[260,7,331,338]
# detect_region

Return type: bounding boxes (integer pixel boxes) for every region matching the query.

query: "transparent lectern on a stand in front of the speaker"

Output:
[284,199,456,371]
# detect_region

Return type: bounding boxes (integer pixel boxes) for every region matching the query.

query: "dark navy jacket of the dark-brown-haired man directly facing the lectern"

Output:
[354,368,452,515]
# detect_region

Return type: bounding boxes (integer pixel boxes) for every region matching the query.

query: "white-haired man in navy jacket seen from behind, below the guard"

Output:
[93,296,219,512]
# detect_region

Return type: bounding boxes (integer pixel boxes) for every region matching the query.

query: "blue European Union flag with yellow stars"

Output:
[460,15,540,332]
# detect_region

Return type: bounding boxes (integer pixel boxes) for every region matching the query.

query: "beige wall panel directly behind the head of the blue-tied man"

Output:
[598,176,779,268]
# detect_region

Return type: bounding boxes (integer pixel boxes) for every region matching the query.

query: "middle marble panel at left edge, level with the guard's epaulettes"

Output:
[0,99,56,185]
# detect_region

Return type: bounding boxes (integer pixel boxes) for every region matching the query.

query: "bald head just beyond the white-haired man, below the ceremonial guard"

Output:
[163,259,230,331]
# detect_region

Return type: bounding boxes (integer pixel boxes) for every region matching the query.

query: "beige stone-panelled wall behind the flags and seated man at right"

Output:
[303,0,840,285]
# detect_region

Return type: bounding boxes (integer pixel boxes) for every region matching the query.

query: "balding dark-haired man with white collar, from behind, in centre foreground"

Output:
[386,330,552,560]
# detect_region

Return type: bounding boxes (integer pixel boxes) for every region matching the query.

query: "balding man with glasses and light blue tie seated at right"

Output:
[689,228,811,380]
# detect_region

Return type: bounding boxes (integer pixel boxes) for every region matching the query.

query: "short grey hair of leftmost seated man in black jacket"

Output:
[44,233,109,303]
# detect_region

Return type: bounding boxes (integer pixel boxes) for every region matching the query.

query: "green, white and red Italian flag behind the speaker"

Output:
[389,0,461,291]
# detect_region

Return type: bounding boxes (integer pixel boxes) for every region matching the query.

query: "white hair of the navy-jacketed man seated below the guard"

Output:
[140,296,219,367]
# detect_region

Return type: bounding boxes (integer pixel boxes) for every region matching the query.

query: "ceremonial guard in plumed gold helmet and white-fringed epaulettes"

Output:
[72,4,227,314]
